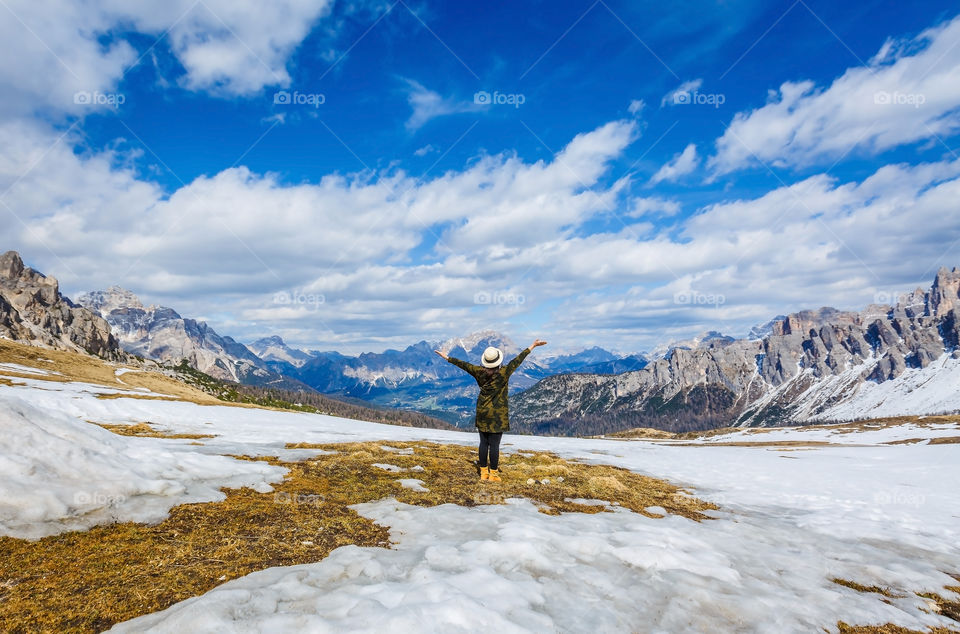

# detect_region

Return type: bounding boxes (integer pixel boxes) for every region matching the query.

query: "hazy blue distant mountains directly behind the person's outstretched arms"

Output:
[249,330,646,424]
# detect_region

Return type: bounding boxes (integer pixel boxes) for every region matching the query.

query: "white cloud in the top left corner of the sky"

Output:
[0,0,332,115]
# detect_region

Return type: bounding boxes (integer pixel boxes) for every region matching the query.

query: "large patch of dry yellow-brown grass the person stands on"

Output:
[0,440,716,632]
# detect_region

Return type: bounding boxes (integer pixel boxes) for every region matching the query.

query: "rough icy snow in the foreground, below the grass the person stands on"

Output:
[111,499,951,634]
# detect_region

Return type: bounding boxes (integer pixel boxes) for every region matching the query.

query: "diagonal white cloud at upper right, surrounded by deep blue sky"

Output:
[708,17,960,176]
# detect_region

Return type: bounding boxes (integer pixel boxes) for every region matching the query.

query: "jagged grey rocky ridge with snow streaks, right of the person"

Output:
[512,268,960,433]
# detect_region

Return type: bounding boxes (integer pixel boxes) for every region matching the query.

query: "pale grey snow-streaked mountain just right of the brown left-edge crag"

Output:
[77,286,276,387]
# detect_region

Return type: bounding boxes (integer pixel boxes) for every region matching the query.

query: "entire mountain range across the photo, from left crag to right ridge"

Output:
[9,247,960,435]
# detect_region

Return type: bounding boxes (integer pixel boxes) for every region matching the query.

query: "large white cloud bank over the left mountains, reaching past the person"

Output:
[0,116,635,345]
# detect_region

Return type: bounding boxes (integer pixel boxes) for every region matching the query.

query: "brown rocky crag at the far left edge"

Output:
[0,251,123,359]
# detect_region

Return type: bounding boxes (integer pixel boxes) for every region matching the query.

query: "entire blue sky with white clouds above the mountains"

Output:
[0,0,960,352]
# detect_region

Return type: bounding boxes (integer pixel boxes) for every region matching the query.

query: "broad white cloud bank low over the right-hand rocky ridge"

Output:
[548,160,960,350]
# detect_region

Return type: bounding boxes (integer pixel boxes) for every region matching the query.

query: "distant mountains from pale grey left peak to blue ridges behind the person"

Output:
[65,278,647,425]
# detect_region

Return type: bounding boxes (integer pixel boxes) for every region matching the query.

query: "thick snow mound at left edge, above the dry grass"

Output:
[0,394,286,539]
